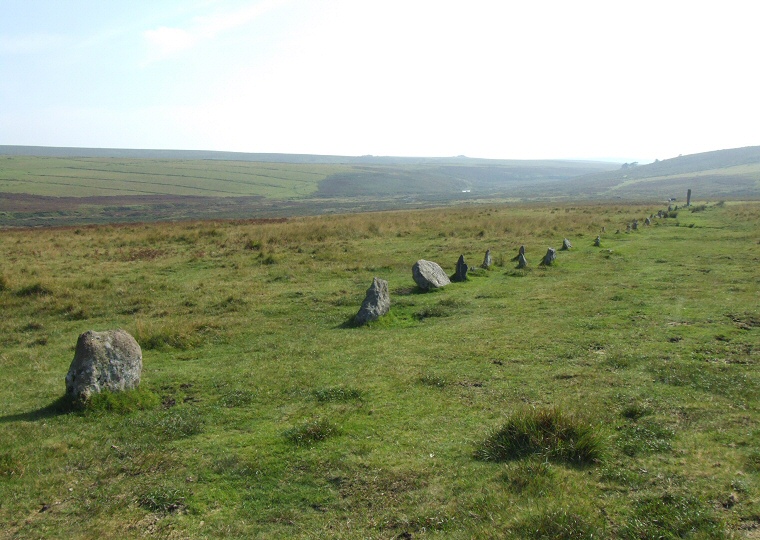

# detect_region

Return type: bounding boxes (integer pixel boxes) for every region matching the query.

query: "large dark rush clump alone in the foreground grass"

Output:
[477,408,603,465]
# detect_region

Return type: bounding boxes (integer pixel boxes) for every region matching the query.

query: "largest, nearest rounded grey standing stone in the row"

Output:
[66,330,142,401]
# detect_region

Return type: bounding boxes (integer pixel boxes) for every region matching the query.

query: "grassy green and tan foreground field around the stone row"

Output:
[0,201,760,539]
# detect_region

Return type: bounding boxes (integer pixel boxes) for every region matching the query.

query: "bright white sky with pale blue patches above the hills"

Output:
[0,0,760,163]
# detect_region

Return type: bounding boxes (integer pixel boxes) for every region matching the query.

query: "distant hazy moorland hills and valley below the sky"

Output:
[0,146,760,227]
